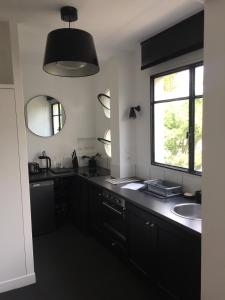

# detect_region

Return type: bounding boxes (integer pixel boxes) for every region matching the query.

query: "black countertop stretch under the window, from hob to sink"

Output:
[89,177,202,235]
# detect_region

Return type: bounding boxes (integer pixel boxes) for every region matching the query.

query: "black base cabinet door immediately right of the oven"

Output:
[127,204,156,278]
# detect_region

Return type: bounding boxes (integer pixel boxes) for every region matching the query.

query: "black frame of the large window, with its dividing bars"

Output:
[150,61,204,176]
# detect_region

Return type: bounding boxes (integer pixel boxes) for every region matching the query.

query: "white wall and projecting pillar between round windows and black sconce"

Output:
[95,52,135,177]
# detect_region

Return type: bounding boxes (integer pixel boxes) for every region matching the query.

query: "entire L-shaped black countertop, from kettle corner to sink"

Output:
[30,167,202,235]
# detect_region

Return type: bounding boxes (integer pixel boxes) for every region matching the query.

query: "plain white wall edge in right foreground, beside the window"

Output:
[202,0,225,300]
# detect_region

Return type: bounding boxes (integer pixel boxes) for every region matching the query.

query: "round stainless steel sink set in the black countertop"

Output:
[171,203,202,220]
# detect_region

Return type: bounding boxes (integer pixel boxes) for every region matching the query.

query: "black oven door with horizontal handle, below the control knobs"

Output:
[102,198,127,244]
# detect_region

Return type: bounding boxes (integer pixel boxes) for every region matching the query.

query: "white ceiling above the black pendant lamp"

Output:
[0,0,203,61]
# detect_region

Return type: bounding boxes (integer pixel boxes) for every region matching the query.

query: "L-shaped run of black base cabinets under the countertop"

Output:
[31,171,201,300]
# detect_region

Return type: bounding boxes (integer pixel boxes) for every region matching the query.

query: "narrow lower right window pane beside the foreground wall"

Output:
[195,98,203,172]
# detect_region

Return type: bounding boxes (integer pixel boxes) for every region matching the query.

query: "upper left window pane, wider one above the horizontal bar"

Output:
[154,70,189,101]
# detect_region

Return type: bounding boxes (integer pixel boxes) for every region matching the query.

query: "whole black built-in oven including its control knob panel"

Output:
[101,190,127,249]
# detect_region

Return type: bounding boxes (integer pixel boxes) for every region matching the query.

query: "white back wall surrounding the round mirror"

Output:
[19,25,97,166]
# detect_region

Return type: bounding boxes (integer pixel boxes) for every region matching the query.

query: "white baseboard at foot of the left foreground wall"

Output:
[0,273,36,293]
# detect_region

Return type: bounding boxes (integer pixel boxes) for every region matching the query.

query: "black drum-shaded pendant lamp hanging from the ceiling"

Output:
[43,6,99,77]
